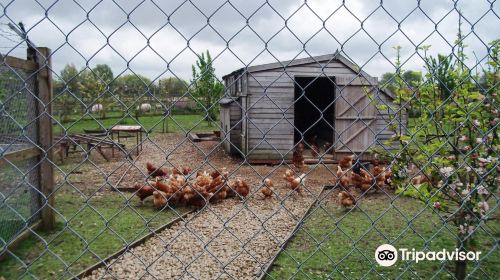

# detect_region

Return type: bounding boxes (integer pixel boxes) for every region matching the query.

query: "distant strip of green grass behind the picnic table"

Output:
[54,113,219,135]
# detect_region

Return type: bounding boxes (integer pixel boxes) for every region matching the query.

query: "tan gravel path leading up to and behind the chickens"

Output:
[81,136,332,279]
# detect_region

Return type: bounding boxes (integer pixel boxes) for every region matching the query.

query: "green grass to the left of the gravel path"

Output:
[0,191,188,279]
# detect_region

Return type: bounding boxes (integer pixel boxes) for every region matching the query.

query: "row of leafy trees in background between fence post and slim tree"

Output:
[52,64,187,122]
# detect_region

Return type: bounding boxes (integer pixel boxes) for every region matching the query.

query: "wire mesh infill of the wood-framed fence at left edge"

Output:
[0,63,41,246]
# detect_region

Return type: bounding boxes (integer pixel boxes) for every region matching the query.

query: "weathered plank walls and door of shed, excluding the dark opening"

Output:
[221,58,394,160]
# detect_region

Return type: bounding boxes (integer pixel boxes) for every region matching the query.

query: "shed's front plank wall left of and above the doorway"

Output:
[244,62,377,159]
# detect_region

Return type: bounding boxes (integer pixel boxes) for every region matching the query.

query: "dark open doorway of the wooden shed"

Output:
[294,77,335,152]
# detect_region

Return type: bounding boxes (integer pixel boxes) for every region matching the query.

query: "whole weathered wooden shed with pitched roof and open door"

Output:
[220,52,400,162]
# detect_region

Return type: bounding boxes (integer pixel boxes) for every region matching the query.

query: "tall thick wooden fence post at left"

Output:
[36,48,55,230]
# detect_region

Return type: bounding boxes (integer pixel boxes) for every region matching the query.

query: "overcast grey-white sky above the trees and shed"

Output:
[0,0,500,80]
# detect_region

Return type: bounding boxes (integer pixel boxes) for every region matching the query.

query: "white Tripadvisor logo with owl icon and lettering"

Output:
[375,244,481,266]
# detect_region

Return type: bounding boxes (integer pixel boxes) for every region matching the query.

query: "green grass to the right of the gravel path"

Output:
[267,196,500,279]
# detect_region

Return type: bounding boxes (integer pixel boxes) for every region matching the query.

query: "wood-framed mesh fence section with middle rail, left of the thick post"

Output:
[0,49,54,250]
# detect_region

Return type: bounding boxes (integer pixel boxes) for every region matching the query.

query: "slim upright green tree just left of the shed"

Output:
[191,50,224,126]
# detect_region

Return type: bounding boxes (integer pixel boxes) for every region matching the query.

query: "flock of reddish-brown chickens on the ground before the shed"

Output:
[134,151,392,209]
